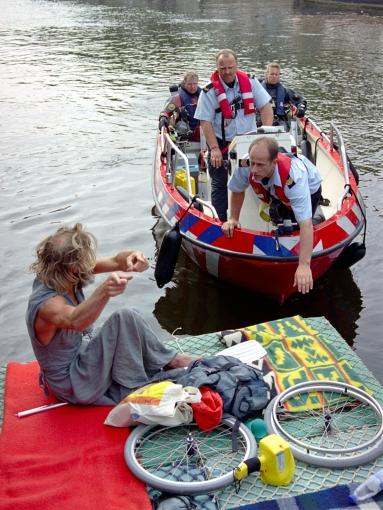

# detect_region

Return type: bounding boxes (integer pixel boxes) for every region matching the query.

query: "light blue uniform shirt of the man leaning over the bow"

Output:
[228,156,322,223]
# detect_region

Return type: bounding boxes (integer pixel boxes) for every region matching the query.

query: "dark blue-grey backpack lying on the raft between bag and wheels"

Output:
[175,355,270,420]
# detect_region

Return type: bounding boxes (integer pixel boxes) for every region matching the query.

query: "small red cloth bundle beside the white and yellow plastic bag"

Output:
[192,386,223,431]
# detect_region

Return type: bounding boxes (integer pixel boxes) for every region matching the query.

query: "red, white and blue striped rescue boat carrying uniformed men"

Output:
[152,117,366,303]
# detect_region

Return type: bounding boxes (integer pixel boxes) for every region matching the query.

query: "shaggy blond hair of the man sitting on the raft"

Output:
[30,223,97,294]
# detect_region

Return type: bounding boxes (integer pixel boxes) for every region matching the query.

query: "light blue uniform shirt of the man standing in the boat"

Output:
[194,74,271,141]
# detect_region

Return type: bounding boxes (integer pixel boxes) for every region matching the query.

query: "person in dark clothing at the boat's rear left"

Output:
[158,71,201,142]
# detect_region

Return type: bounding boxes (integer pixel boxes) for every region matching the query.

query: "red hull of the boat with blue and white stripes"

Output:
[153,121,364,303]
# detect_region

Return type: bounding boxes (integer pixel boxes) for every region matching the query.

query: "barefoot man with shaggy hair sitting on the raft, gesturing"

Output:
[26,223,195,405]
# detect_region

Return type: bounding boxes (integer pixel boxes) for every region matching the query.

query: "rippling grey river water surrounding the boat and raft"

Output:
[0,0,383,382]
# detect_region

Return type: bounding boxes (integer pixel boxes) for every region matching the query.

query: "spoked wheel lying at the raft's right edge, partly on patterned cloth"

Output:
[265,381,383,468]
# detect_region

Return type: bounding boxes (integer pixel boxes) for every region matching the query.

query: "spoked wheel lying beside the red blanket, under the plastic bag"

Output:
[124,418,257,495]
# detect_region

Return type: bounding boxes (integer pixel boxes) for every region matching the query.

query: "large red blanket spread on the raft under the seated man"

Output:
[0,362,151,510]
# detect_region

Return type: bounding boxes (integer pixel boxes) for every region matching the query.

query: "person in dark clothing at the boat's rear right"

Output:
[260,62,307,127]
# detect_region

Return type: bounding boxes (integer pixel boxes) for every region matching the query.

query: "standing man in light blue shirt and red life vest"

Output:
[195,49,273,221]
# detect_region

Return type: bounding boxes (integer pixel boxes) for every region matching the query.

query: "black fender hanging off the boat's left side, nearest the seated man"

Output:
[154,223,182,289]
